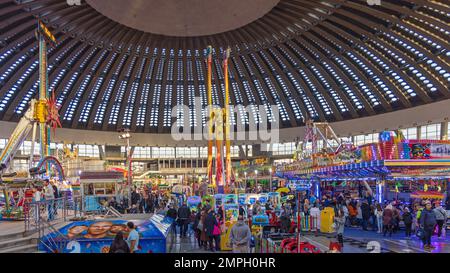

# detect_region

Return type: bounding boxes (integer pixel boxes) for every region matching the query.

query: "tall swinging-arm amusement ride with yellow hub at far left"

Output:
[0,20,64,219]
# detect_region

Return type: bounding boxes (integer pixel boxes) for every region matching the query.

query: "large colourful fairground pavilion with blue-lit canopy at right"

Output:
[278,131,450,202]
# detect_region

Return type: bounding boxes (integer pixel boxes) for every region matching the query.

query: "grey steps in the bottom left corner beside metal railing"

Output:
[0,232,39,253]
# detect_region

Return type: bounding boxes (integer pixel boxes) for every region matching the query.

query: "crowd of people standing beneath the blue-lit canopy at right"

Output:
[299,189,448,250]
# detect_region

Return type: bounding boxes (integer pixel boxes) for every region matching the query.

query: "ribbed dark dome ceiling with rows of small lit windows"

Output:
[0,0,450,133]
